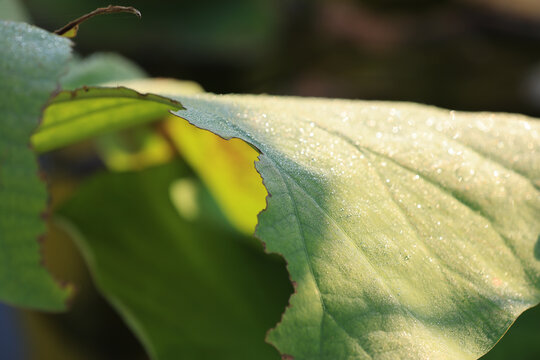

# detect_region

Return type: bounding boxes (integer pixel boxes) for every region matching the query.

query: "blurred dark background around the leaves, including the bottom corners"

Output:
[0,0,540,360]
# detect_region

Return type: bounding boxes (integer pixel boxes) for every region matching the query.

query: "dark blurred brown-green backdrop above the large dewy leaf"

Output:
[24,0,540,115]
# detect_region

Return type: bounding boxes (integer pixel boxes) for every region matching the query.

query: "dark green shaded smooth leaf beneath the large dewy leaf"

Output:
[58,163,292,360]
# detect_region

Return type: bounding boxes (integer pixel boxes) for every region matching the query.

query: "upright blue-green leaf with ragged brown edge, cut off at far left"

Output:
[0,21,70,310]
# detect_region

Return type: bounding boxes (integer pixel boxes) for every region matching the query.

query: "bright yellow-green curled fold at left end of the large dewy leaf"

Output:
[31,79,205,152]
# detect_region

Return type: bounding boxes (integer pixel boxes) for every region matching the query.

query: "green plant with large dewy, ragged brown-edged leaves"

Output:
[0,8,540,359]
